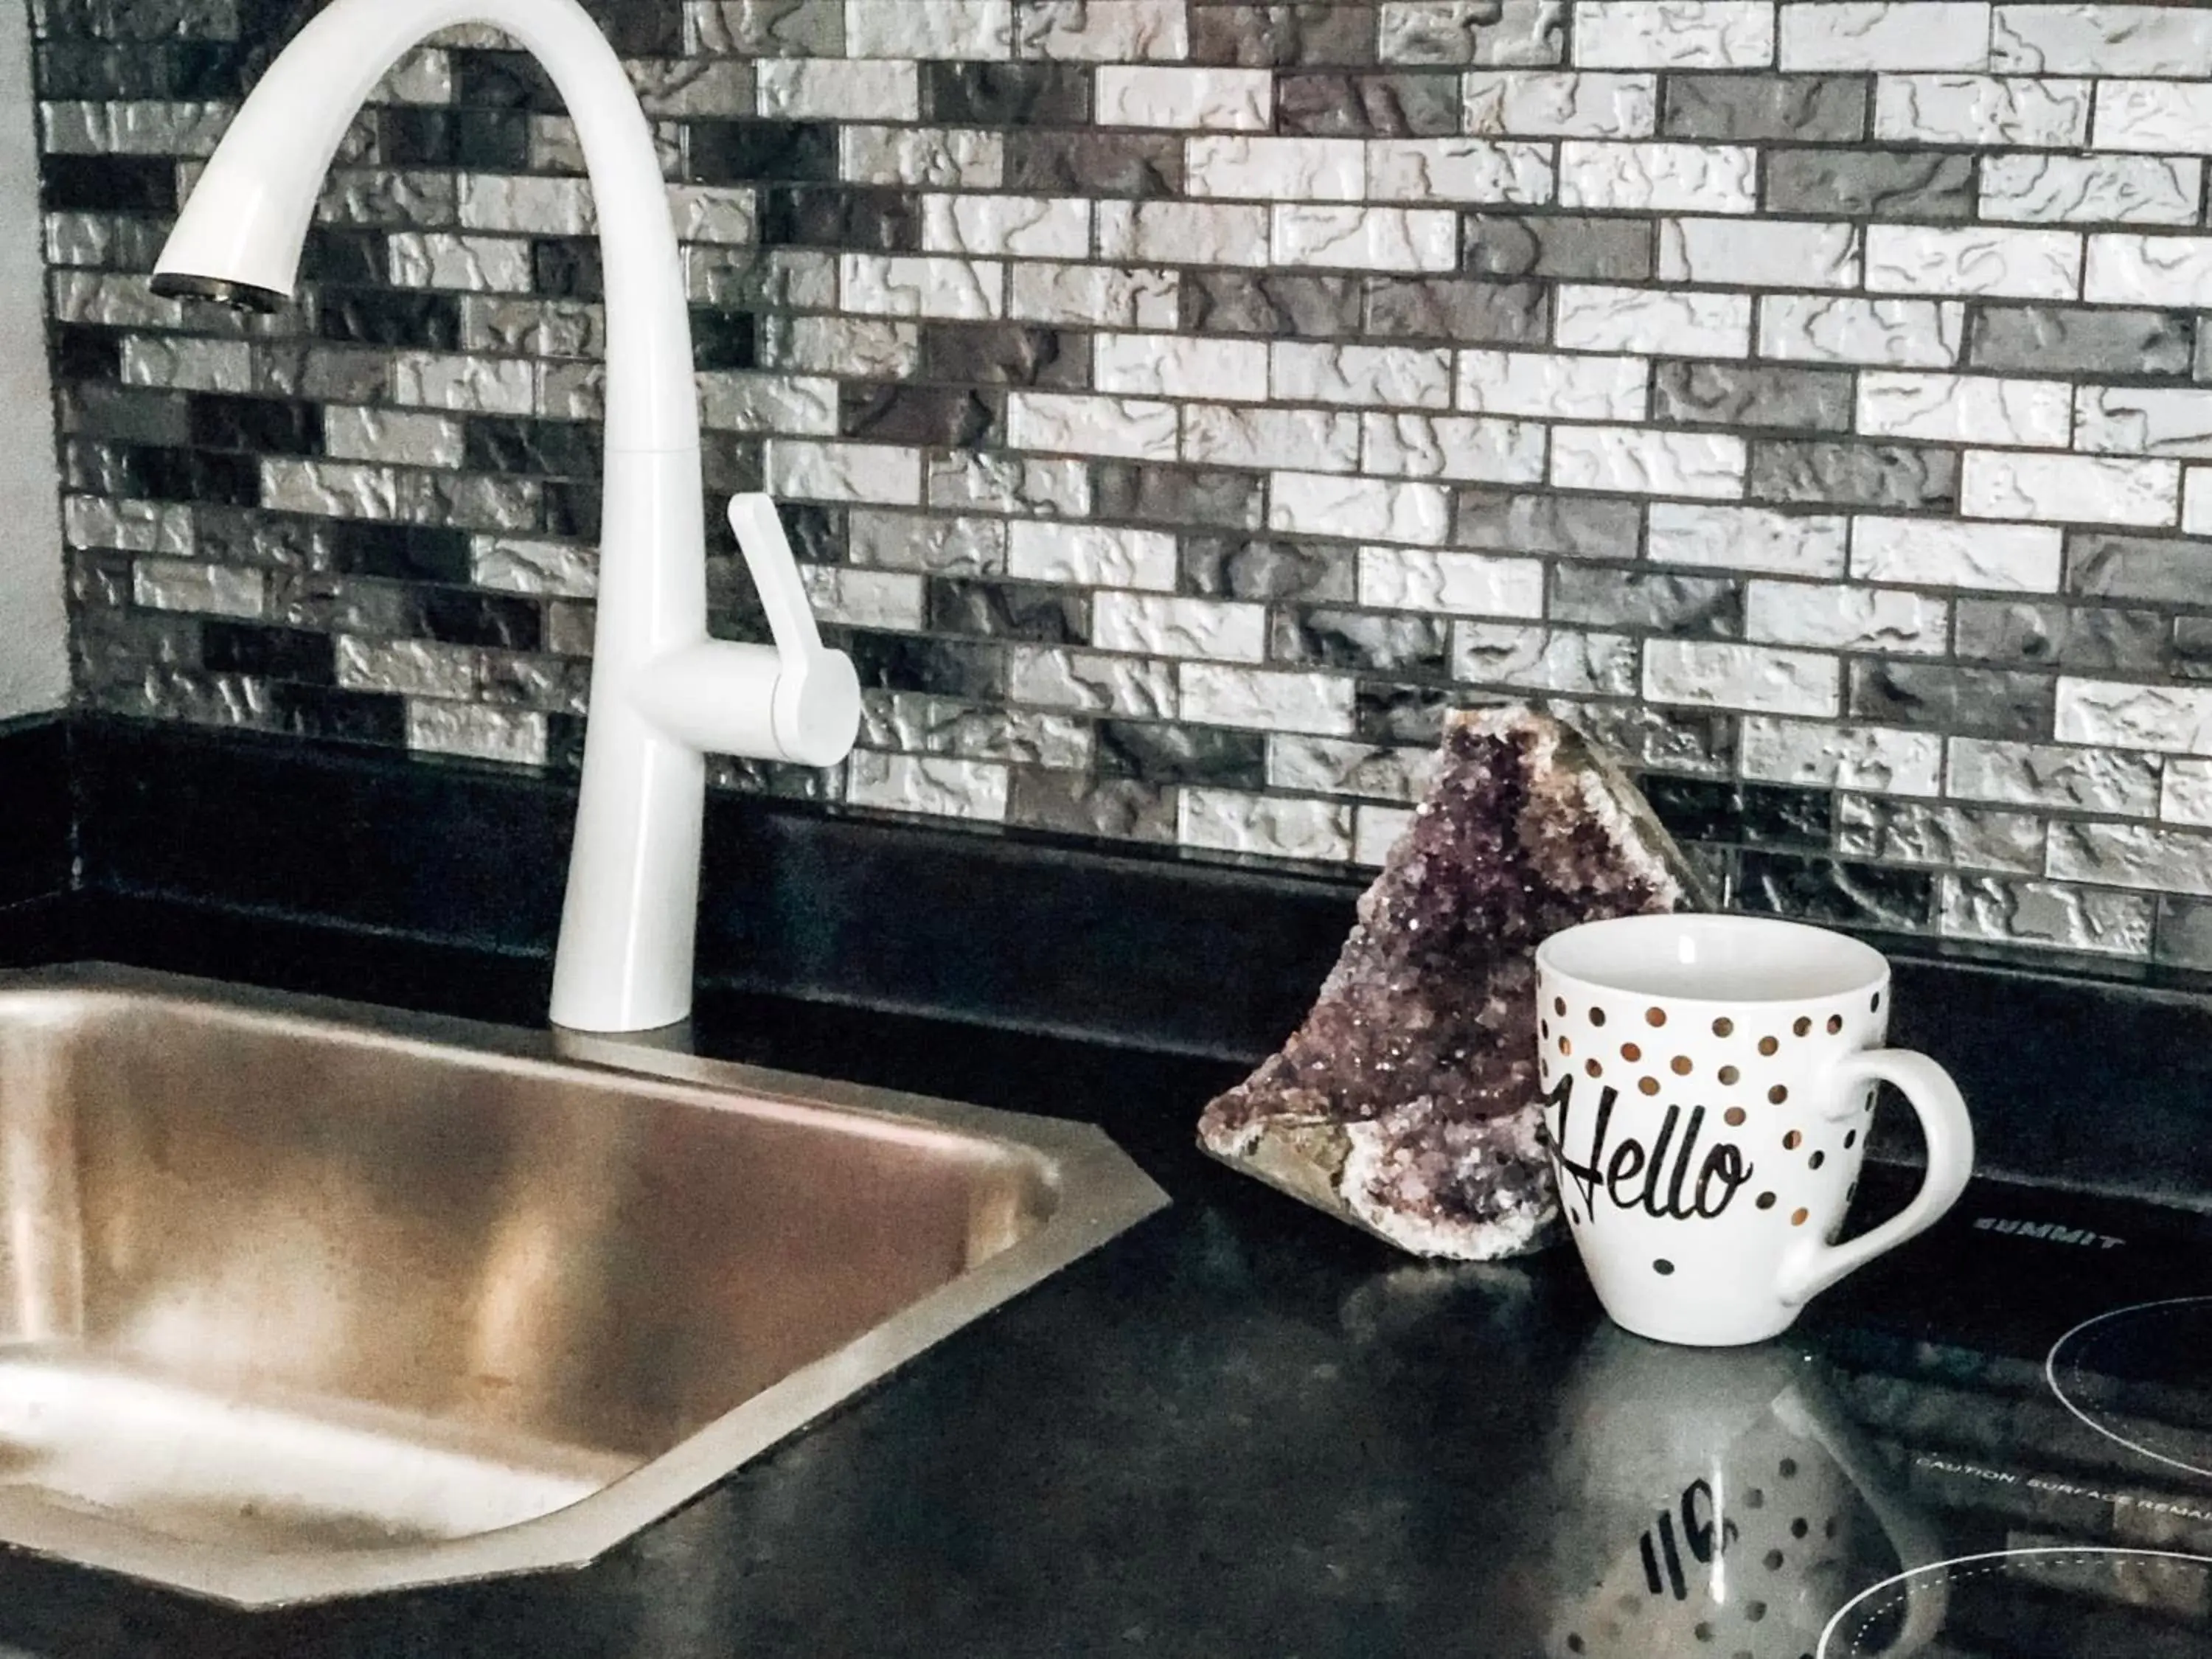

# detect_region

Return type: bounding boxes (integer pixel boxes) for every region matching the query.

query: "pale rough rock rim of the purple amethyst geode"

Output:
[1199,703,1712,1261]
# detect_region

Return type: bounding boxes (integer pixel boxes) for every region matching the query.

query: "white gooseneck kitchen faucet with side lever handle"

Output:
[153,0,860,1031]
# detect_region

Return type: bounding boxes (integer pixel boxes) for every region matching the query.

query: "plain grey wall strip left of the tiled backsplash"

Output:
[0,7,69,719]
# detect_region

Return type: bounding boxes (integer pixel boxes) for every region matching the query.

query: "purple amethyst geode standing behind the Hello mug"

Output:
[1199,708,1699,1261]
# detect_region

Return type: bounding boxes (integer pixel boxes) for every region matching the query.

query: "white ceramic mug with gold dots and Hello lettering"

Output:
[1535,916,1973,1347]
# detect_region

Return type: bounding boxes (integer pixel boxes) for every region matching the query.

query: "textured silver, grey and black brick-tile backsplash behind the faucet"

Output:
[42,0,2212,967]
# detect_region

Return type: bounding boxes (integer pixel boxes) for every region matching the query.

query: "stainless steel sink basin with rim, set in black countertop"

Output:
[0,964,1166,1606]
